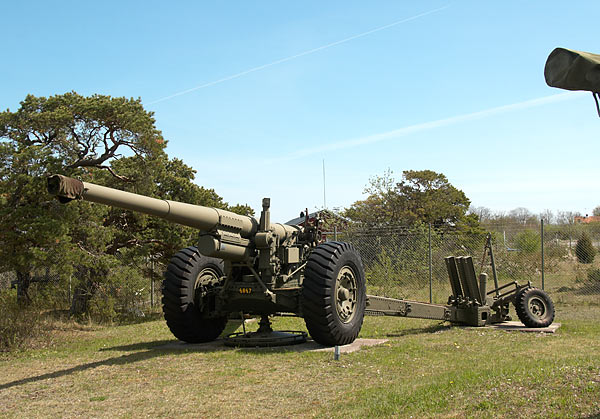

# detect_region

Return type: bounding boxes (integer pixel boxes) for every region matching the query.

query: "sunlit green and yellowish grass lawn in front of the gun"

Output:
[0,306,600,418]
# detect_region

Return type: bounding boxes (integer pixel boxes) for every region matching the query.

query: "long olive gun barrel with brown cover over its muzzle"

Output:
[48,175,258,238]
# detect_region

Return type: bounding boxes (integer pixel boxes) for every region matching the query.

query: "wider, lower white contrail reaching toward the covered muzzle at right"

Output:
[270,92,584,162]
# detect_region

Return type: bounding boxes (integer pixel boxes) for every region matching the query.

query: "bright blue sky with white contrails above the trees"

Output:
[0,0,600,221]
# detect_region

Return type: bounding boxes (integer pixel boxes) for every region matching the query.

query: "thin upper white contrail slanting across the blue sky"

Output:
[148,6,449,105]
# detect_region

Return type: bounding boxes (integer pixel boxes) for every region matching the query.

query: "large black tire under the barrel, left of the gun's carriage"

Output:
[162,247,227,343]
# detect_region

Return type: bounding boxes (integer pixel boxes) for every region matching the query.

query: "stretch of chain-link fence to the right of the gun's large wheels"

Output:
[329,224,600,311]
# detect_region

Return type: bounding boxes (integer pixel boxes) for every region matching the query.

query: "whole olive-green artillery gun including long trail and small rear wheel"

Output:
[48,175,554,346]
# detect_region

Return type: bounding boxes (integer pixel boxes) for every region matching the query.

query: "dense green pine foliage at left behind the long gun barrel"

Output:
[0,92,252,322]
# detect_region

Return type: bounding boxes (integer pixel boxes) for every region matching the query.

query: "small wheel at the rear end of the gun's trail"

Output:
[515,288,554,327]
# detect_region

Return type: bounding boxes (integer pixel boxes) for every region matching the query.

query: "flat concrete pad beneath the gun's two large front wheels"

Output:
[156,339,388,354]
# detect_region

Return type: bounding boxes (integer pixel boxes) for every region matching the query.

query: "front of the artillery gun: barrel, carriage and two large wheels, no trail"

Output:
[48,175,366,345]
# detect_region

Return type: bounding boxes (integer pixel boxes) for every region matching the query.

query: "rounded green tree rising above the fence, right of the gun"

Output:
[344,170,478,228]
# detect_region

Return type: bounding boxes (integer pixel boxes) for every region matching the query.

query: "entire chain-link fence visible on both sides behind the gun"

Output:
[0,224,600,318]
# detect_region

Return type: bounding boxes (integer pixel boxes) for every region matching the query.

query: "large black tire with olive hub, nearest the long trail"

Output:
[301,242,367,346]
